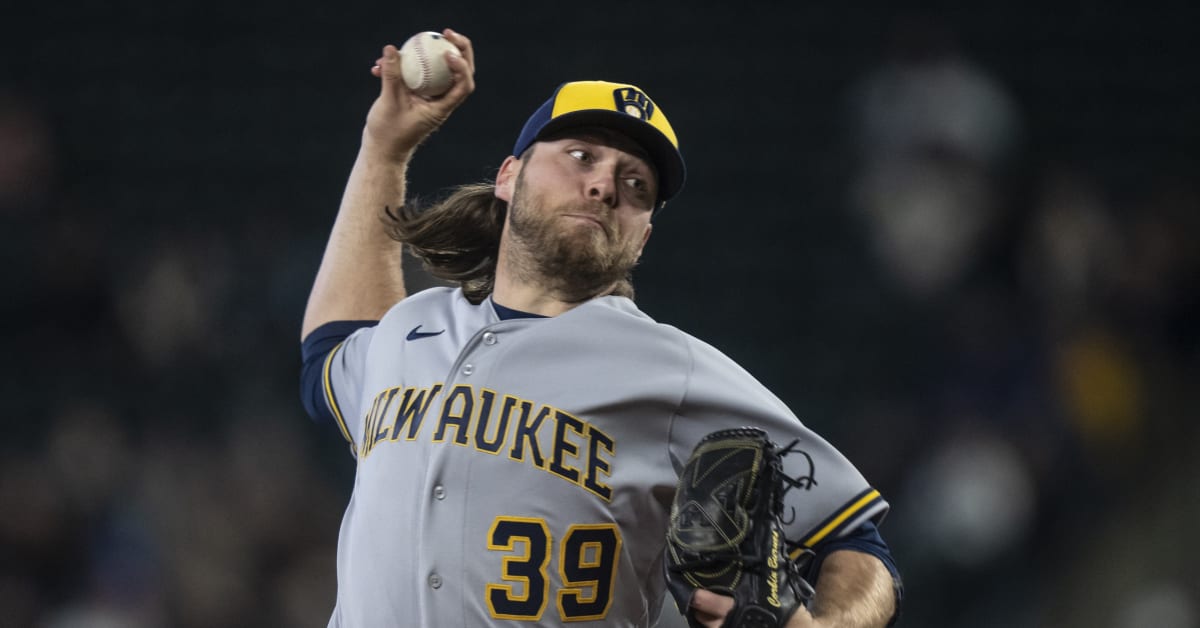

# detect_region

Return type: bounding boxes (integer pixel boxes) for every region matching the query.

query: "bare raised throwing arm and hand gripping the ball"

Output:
[300,29,475,339]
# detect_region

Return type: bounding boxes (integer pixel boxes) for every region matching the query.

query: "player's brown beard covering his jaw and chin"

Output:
[509,172,641,303]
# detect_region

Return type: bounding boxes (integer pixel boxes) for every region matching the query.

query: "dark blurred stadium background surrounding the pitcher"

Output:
[0,0,1200,628]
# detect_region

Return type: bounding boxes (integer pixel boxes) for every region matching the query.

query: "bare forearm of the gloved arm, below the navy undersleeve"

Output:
[812,550,895,628]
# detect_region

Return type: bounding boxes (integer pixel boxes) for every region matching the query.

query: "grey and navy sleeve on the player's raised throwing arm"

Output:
[300,321,377,450]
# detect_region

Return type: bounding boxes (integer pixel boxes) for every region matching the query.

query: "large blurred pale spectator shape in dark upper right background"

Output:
[850,14,1020,299]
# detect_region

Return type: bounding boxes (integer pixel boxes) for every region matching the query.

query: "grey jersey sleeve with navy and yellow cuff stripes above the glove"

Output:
[670,336,888,556]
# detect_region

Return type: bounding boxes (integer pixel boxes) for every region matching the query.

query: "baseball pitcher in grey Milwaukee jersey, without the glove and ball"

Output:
[302,30,899,627]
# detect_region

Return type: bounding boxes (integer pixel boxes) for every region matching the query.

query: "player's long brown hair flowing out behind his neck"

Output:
[384,171,634,304]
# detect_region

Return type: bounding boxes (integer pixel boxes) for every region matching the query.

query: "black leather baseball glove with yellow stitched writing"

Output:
[664,427,812,628]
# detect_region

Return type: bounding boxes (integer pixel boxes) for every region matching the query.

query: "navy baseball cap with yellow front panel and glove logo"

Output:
[512,80,688,208]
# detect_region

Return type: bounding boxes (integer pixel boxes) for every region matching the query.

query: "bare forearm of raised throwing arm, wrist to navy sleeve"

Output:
[300,137,410,339]
